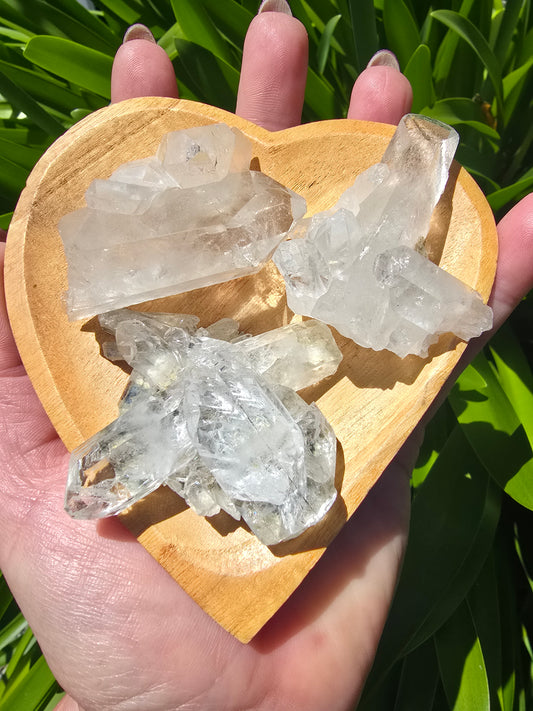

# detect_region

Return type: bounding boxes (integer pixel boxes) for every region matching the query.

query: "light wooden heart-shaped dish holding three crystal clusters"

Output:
[6,98,497,641]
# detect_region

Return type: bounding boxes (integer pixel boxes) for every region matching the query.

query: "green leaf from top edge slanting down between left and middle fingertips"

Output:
[171,0,234,66]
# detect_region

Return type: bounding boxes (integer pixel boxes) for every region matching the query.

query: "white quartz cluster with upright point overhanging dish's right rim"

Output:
[273,114,492,358]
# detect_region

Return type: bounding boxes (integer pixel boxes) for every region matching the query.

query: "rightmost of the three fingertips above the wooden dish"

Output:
[348,50,413,124]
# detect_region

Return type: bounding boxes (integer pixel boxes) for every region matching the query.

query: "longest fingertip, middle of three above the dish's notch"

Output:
[236,2,308,131]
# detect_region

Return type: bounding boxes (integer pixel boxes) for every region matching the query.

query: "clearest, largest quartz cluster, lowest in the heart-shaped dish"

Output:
[65,309,342,545]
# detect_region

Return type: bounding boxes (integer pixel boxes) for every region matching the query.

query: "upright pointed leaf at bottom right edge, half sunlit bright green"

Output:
[435,603,490,711]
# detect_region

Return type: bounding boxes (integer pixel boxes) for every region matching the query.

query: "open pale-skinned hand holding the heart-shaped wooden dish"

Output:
[0,2,533,711]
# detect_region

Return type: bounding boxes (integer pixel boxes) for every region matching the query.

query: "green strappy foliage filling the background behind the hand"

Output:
[0,0,533,711]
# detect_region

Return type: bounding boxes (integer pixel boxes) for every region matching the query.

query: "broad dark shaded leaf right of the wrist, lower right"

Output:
[362,426,501,688]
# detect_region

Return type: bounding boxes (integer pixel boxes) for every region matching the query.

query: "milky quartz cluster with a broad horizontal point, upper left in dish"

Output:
[59,124,306,320]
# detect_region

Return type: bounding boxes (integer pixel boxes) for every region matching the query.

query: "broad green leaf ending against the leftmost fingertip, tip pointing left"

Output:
[24,36,113,99]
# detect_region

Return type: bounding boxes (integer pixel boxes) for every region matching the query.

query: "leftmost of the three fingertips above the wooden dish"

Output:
[111,25,178,103]
